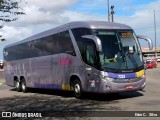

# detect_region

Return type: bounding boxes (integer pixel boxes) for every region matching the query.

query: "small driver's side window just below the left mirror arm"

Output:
[85,44,96,65]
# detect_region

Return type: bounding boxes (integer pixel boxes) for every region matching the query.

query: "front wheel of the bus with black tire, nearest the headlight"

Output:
[74,79,83,99]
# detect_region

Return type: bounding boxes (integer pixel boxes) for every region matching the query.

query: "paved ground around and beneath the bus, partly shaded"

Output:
[0,64,160,120]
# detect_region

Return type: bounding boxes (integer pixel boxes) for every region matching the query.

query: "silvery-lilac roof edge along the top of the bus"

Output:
[4,21,132,48]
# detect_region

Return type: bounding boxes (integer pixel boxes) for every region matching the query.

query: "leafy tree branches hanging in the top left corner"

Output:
[0,0,25,41]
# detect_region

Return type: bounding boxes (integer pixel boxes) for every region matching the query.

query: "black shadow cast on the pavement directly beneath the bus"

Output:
[10,88,143,102]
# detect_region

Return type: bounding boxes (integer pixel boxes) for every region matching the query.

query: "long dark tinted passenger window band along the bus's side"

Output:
[4,31,75,60]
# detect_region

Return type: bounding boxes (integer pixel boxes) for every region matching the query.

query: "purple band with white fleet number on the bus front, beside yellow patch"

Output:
[108,73,136,79]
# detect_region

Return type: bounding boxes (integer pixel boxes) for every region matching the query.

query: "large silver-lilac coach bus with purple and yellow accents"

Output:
[3,21,152,98]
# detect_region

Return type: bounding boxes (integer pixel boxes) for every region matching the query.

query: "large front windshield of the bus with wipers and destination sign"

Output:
[93,30,143,72]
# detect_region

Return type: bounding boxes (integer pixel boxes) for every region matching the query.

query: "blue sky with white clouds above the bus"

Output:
[0,0,160,59]
